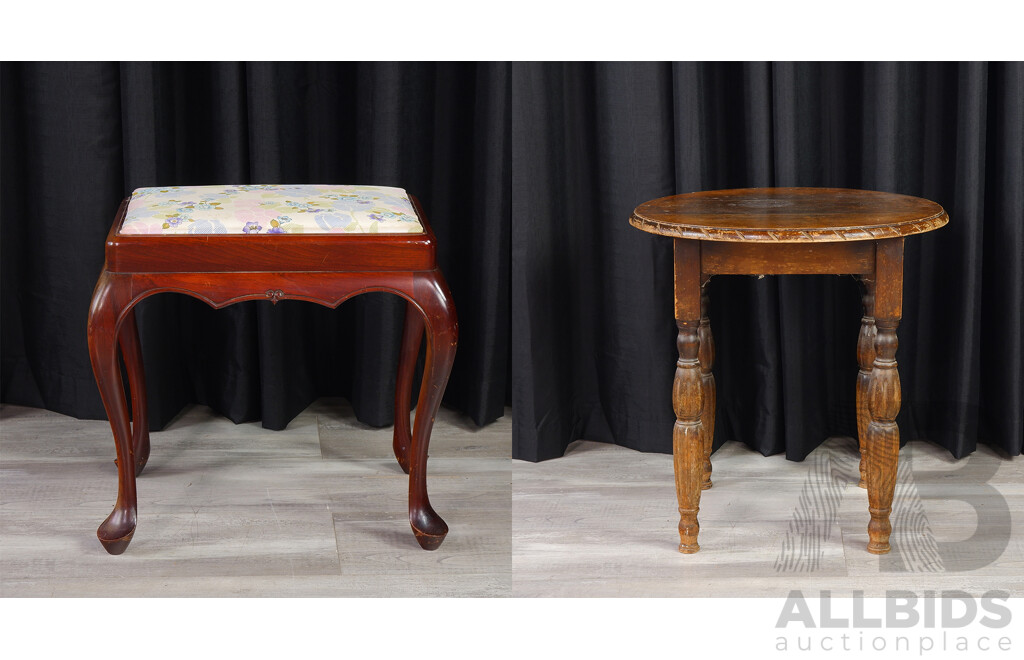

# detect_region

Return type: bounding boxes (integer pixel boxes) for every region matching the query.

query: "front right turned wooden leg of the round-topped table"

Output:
[866,238,903,555]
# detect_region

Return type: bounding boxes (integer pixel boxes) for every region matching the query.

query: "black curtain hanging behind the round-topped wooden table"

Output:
[511,63,1024,460]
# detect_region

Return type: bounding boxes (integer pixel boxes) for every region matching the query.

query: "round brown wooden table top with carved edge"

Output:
[630,188,949,243]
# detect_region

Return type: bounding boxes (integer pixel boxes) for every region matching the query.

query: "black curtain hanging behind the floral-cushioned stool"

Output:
[0,63,511,429]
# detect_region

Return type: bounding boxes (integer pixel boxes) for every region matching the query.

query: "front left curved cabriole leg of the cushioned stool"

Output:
[88,270,136,555]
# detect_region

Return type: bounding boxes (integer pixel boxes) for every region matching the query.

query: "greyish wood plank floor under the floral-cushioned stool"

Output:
[0,399,512,597]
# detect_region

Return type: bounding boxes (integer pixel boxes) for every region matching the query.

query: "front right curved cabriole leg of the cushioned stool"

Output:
[407,270,459,549]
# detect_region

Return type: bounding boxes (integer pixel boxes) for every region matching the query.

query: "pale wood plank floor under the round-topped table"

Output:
[512,438,1024,597]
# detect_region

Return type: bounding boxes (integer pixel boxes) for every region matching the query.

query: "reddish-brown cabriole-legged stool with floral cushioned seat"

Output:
[88,184,458,555]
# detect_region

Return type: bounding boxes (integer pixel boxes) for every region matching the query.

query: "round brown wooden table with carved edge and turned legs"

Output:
[630,188,949,555]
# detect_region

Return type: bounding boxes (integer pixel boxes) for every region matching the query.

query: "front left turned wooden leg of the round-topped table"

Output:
[672,239,705,554]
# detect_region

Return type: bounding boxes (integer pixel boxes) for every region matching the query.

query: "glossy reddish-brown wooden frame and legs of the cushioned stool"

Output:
[88,195,458,555]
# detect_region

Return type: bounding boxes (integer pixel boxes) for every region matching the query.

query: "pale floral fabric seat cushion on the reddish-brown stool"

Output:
[120,184,423,235]
